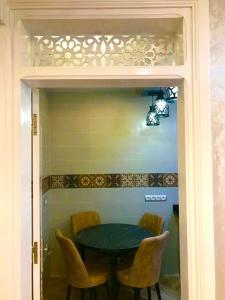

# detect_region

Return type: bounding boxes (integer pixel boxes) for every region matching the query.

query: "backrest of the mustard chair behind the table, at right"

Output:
[139,213,164,235]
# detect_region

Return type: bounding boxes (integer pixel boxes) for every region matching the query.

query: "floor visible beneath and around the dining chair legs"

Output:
[44,278,180,300]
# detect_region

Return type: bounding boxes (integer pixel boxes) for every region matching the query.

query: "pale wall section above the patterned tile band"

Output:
[48,89,177,174]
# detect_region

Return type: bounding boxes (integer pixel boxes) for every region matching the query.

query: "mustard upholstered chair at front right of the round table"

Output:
[117,231,169,300]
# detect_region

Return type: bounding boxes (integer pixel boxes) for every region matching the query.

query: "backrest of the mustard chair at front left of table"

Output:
[55,229,90,288]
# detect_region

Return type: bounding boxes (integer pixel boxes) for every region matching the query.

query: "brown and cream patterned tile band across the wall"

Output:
[42,173,178,193]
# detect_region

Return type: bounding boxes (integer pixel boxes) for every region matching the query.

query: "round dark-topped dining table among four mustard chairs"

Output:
[76,223,153,300]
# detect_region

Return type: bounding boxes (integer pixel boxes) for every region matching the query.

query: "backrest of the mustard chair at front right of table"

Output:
[129,231,169,288]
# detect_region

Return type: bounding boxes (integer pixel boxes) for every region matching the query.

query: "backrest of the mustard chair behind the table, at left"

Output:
[71,211,101,238]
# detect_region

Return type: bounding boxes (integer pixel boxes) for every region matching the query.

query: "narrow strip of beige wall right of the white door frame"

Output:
[210,0,225,300]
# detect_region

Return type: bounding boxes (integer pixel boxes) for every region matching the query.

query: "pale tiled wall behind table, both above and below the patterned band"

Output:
[40,89,178,276]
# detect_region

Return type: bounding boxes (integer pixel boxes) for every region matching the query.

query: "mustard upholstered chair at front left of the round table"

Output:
[55,229,109,300]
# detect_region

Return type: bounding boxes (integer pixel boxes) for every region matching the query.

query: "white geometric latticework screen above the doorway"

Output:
[32,34,182,67]
